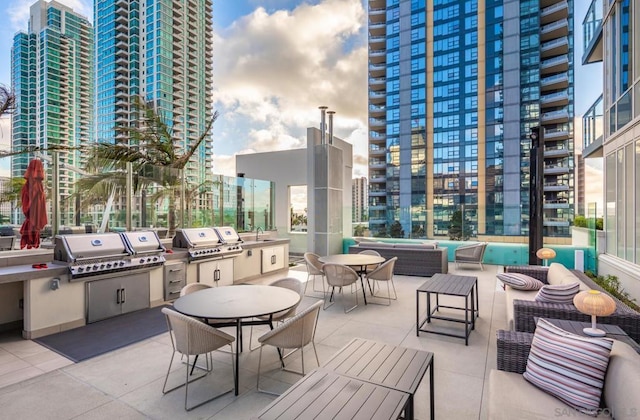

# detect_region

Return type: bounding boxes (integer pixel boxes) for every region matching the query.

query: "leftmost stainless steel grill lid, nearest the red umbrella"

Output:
[54,233,131,262]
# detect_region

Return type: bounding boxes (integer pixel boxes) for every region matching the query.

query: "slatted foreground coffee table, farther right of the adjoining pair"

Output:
[322,338,435,420]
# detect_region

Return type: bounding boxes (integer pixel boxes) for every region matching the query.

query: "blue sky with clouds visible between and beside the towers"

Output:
[0,0,602,184]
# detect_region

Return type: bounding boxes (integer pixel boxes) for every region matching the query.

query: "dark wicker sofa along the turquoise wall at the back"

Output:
[349,242,449,277]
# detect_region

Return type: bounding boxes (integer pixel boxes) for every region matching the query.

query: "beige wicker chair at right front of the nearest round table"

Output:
[256,301,322,395]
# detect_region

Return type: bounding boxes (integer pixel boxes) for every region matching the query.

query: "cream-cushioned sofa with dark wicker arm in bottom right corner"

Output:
[488,330,640,420]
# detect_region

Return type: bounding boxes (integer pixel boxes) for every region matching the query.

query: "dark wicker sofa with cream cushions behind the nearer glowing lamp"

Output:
[504,263,640,342]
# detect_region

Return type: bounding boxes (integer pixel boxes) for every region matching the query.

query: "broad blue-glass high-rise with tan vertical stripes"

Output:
[369,0,574,242]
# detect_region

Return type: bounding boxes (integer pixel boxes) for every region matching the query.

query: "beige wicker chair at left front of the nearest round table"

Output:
[162,308,238,411]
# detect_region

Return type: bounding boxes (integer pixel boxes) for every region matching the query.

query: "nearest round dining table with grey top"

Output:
[173,284,300,395]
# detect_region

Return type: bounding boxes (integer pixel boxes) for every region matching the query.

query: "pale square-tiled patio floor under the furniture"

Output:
[0,264,506,420]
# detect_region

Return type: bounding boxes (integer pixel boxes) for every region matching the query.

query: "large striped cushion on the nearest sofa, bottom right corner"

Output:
[523,319,613,416]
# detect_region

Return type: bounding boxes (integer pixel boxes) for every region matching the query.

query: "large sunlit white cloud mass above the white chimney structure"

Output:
[214,0,367,177]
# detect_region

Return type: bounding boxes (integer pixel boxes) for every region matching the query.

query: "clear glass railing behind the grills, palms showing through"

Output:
[0,146,275,248]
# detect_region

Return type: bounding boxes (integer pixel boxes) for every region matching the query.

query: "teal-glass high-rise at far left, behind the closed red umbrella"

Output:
[11,0,94,223]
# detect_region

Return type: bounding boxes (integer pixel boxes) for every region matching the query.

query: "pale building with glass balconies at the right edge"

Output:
[582,0,640,297]
